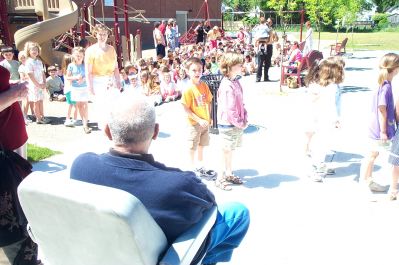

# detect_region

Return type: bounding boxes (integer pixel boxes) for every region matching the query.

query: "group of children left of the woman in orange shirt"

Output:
[0,42,91,133]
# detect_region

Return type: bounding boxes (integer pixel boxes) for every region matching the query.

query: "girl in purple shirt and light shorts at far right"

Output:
[359,53,399,193]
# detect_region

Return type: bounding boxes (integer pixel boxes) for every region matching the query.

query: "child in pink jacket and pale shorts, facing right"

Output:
[215,52,248,190]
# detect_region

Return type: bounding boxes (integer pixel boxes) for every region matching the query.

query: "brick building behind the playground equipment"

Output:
[0,0,221,48]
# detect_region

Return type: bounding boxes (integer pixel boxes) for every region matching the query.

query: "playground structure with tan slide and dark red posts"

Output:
[0,0,148,67]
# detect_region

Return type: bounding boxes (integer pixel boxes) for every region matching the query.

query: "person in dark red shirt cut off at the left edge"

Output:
[0,66,38,265]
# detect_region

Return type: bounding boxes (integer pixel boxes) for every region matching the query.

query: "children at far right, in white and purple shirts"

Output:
[305,53,399,200]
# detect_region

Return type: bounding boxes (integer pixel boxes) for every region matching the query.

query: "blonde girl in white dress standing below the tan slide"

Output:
[24,41,50,124]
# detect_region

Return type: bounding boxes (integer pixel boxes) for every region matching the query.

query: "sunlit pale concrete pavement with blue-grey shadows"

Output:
[3,51,399,265]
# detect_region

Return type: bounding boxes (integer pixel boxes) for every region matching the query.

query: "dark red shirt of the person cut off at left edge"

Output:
[0,66,28,150]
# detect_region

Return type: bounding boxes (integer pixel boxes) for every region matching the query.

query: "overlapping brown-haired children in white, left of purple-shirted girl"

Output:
[305,57,344,182]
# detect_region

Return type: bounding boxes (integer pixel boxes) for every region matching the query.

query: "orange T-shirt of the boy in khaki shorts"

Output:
[181,82,212,125]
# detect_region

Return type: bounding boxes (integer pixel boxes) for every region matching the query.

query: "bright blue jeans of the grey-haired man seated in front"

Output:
[202,202,249,264]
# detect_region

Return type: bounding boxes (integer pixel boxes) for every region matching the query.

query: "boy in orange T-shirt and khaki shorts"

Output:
[181,57,216,178]
